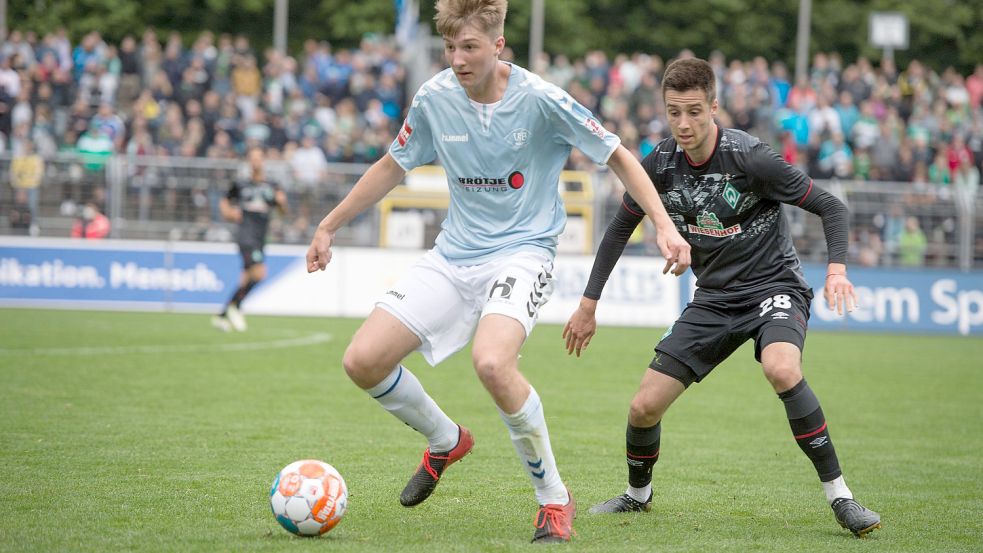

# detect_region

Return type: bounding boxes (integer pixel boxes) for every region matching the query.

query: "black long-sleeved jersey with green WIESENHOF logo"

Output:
[585,127,847,300]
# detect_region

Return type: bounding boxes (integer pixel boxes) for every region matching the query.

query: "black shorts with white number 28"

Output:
[650,288,812,385]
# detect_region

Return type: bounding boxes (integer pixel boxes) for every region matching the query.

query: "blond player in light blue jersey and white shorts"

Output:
[307,0,690,543]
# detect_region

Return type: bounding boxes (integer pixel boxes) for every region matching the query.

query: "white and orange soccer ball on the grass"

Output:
[270,459,348,536]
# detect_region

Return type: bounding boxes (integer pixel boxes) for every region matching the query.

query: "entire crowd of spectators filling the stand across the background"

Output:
[0,29,983,266]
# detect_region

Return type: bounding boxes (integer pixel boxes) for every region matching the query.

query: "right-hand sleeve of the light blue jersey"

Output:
[540,85,621,165]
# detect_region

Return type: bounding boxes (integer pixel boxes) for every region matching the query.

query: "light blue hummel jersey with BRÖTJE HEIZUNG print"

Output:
[389,61,621,265]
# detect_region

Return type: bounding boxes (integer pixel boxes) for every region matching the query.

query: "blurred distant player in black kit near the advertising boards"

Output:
[212,147,287,332]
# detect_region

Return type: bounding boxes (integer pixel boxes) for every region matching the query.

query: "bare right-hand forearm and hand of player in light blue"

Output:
[608,146,691,276]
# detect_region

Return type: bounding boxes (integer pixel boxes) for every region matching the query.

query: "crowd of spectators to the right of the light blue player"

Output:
[533,47,983,266]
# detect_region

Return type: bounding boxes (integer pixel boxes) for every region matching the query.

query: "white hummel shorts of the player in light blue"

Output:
[376,250,553,365]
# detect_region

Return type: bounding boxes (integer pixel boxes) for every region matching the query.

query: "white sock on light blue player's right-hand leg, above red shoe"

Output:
[498,387,570,505]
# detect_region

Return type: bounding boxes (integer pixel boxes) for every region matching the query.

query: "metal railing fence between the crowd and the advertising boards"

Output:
[0,154,983,270]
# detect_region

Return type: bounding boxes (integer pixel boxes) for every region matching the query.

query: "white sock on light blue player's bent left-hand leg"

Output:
[365,365,458,452]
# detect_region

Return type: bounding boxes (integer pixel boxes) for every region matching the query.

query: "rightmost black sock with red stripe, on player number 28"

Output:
[778,378,843,482]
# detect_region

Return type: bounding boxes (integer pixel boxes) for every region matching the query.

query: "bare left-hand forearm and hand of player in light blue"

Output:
[307,153,406,273]
